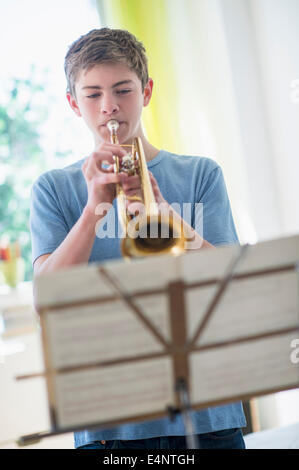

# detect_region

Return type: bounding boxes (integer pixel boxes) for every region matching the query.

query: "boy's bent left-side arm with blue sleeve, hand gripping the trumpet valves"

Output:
[31,143,126,275]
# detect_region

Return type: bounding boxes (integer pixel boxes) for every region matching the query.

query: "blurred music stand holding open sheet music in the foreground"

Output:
[19,236,299,448]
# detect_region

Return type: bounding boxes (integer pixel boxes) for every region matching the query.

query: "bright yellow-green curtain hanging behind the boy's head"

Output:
[97,0,182,153]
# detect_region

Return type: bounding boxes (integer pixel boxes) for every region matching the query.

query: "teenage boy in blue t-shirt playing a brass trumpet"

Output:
[31,28,246,449]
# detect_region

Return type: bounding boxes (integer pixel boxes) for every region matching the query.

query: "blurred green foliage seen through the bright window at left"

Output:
[0,68,67,280]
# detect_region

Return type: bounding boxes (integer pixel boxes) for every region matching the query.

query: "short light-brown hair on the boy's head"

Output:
[64,28,149,96]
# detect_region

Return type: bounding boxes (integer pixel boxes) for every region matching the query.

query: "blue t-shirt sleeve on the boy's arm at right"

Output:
[199,166,239,246]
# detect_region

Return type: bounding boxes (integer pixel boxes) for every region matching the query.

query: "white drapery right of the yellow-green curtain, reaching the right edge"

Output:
[167,0,299,248]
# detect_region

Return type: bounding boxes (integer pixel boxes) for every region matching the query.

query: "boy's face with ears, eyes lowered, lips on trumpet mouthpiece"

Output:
[67,64,153,144]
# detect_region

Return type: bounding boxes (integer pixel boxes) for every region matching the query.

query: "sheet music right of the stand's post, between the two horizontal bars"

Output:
[186,271,299,345]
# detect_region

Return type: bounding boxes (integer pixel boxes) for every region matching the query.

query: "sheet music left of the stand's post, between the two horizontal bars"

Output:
[46,296,169,368]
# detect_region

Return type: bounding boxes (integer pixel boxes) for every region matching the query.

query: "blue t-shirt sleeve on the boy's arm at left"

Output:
[30,176,68,263]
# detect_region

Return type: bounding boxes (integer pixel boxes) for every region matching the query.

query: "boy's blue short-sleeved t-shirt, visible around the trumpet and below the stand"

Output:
[30,150,246,447]
